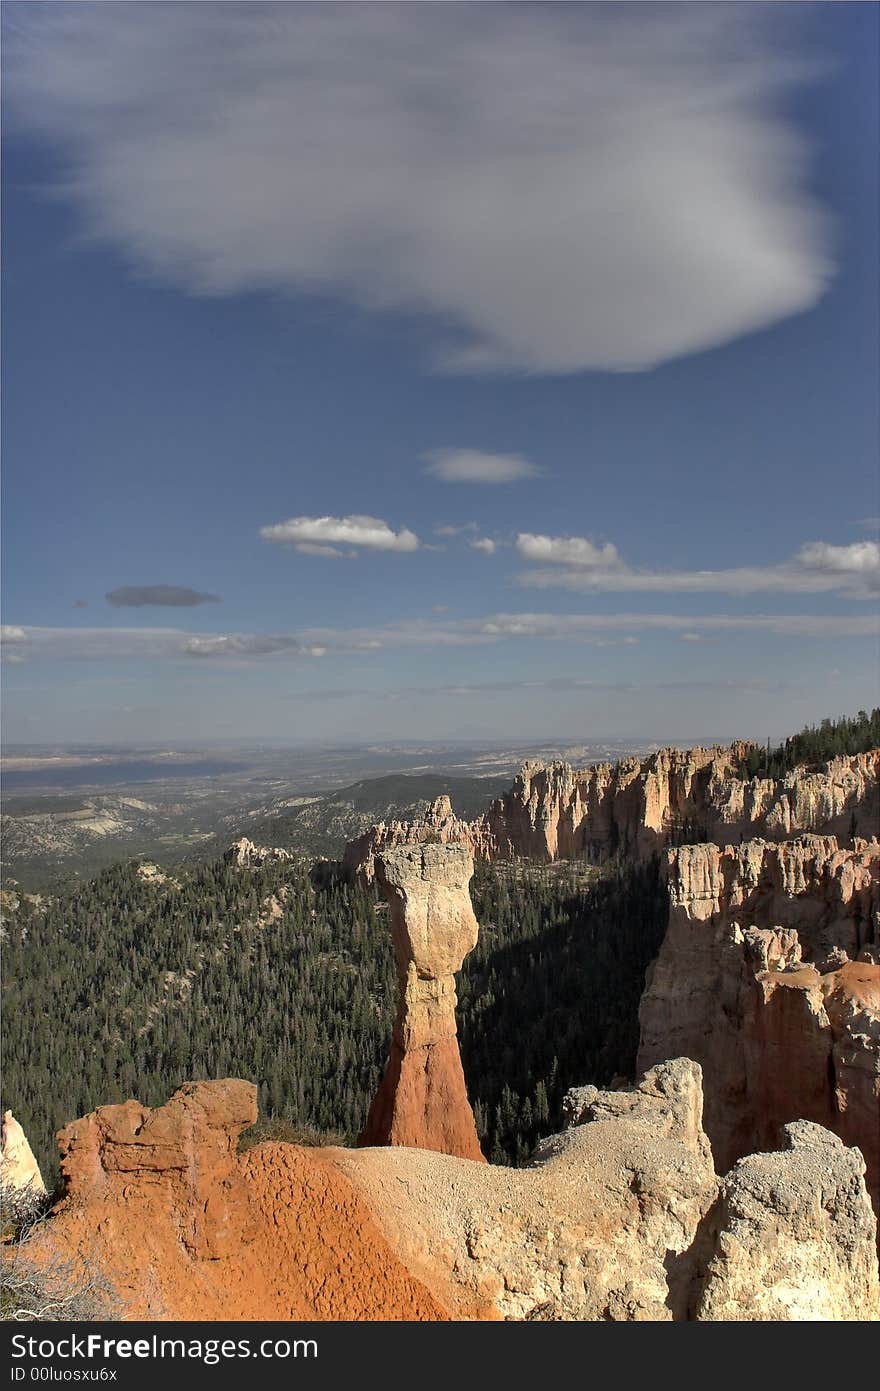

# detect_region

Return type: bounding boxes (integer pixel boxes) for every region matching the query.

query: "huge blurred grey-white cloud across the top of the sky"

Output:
[7,3,833,373]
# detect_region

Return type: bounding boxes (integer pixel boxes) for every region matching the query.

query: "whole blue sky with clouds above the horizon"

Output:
[3,3,880,743]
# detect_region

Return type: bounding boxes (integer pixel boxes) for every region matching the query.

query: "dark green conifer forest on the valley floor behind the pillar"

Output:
[3,860,666,1184]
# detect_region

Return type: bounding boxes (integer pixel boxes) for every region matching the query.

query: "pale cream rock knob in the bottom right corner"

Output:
[695,1121,877,1321]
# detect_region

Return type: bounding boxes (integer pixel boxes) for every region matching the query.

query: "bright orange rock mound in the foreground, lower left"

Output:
[39,1079,446,1321]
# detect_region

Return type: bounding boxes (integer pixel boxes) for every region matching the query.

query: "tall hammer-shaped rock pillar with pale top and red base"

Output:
[359,844,482,1159]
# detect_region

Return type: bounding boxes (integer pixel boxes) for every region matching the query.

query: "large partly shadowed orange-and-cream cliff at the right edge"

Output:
[638,836,880,1203]
